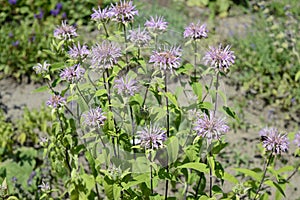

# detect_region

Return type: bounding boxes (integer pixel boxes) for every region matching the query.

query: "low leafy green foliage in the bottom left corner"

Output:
[0,106,51,199]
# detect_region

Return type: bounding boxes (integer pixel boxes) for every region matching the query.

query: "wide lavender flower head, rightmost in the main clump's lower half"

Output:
[194,112,229,141]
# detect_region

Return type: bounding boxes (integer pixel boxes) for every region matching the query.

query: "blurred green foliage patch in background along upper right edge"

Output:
[231,3,300,112]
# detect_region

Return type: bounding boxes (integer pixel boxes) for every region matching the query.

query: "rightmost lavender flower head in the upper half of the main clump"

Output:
[204,44,235,72]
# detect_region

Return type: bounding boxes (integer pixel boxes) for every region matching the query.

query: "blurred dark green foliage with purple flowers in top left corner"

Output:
[0,0,97,82]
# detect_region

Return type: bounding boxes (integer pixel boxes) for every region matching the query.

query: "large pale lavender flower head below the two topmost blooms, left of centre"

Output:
[90,40,122,69]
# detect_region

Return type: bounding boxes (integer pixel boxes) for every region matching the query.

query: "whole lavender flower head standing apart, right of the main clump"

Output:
[259,127,289,154]
